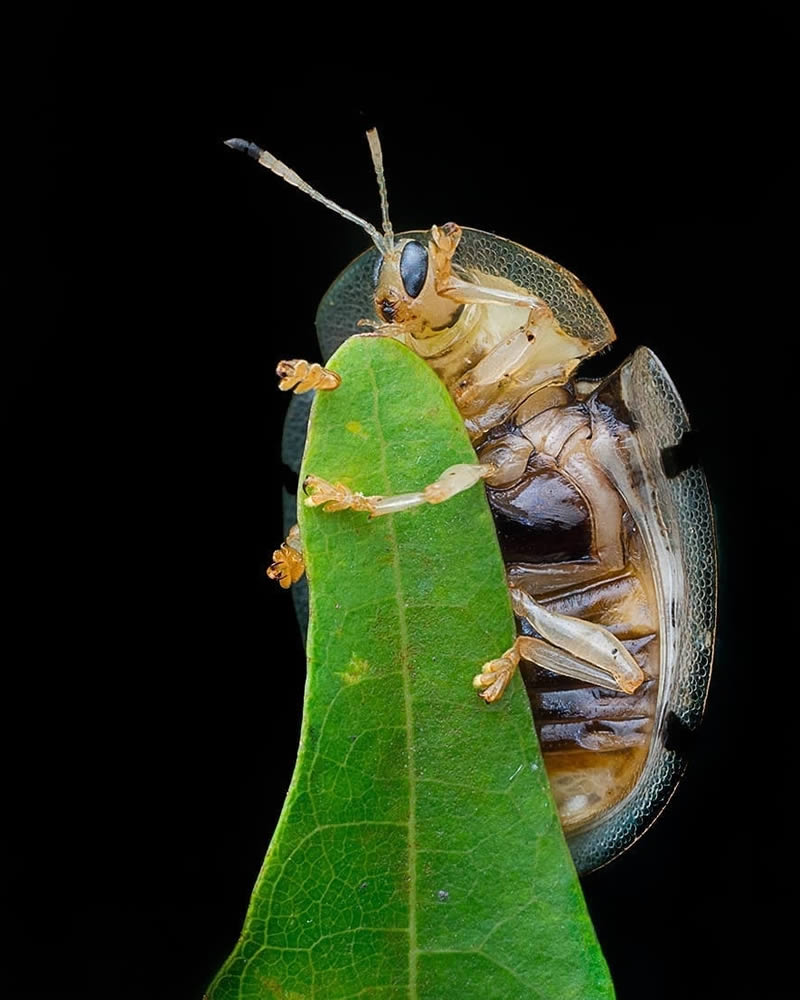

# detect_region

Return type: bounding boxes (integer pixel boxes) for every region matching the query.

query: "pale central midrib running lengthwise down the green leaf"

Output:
[368,359,418,1000]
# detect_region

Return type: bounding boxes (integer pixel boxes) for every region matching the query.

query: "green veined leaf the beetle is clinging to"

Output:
[209,337,614,1000]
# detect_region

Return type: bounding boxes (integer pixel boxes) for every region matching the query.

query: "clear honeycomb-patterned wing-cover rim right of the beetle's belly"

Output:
[569,347,717,872]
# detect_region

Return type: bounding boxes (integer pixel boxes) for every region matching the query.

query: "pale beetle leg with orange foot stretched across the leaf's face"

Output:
[303,464,496,517]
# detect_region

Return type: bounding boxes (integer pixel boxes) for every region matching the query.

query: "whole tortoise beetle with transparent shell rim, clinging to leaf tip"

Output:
[228,130,716,873]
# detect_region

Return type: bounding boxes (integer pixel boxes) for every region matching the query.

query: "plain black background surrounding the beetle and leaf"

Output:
[3,11,787,1000]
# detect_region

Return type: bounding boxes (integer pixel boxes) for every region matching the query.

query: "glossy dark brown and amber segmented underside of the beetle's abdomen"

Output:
[488,442,659,832]
